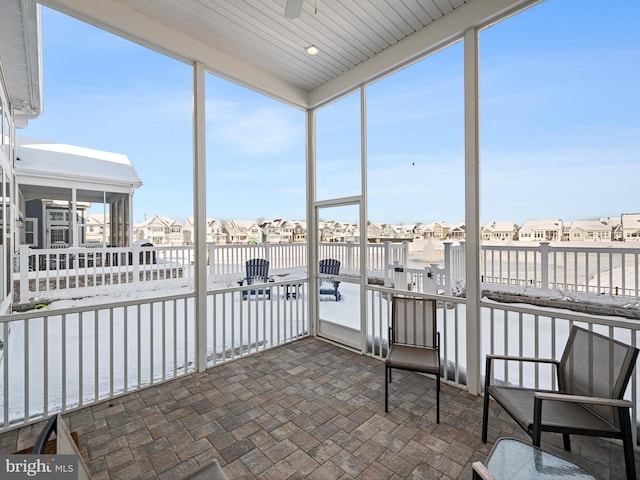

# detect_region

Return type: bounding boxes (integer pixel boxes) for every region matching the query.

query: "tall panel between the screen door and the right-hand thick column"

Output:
[367,43,465,293]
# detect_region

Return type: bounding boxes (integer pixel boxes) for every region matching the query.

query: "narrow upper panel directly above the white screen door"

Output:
[316,91,362,200]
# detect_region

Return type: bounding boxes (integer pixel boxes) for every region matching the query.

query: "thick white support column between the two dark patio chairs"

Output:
[464,28,481,394]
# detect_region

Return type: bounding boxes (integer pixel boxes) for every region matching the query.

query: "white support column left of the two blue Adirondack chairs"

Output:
[193,62,207,372]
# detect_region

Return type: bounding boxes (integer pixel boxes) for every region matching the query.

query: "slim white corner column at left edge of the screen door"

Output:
[305,110,318,336]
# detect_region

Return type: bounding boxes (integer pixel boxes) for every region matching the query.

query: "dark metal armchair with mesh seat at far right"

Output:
[482,326,638,479]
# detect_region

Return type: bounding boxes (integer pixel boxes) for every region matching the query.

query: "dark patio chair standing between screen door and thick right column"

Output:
[384,296,440,423]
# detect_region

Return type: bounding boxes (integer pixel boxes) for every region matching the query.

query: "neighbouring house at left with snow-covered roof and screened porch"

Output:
[15,137,142,248]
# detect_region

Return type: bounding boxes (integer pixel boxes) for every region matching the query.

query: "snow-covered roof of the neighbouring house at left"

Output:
[15,137,142,190]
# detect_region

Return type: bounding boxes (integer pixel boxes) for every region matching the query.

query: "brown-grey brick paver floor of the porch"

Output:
[0,338,640,480]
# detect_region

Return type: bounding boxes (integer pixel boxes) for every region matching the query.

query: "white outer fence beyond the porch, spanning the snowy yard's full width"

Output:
[15,241,640,303]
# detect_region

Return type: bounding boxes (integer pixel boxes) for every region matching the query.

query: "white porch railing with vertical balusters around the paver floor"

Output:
[0,279,640,444]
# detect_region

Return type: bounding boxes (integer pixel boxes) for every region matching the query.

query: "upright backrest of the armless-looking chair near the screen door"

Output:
[391,297,438,348]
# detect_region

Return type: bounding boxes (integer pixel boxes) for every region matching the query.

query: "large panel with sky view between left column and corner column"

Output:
[205,74,306,225]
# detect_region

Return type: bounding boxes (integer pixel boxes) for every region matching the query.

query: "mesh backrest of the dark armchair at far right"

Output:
[559,326,638,425]
